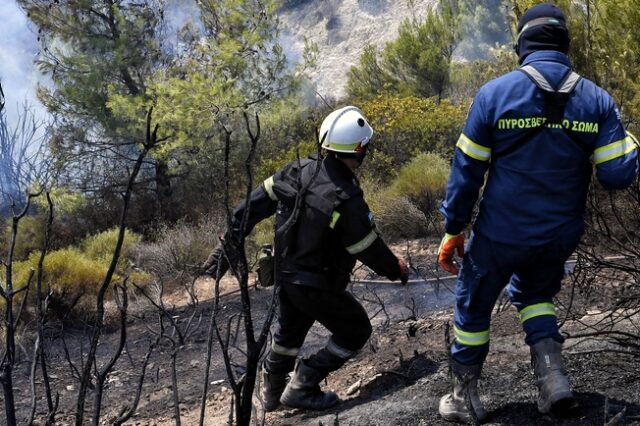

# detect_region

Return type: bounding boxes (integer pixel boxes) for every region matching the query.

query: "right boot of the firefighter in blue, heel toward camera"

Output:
[531,338,576,415]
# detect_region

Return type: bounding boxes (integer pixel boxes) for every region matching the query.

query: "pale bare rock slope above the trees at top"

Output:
[281,0,438,98]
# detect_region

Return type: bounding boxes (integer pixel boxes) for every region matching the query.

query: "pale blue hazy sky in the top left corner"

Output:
[0,0,47,126]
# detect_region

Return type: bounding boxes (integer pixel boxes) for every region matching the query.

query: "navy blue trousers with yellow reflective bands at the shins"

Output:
[451,231,580,365]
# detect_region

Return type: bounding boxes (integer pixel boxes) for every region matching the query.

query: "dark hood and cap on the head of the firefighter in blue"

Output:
[515,3,569,63]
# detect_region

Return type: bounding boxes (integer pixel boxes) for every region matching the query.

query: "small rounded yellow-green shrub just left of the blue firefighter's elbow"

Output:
[391,152,450,216]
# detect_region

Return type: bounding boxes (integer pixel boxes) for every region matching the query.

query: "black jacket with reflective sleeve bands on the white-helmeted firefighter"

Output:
[232,156,400,291]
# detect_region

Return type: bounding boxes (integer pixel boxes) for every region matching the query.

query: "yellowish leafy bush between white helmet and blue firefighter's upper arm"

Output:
[361,96,468,182]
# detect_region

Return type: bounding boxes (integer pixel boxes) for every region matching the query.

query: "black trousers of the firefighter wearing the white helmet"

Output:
[267,282,372,373]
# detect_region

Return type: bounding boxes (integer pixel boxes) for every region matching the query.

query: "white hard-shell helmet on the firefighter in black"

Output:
[319,106,373,154]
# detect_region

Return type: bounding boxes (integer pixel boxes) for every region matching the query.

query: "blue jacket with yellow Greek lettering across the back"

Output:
[440,51,638,245]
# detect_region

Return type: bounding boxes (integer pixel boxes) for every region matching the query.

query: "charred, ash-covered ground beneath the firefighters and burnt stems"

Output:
[7,241,640,426]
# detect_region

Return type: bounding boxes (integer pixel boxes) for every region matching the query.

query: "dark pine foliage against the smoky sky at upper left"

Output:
[18,0,162,138]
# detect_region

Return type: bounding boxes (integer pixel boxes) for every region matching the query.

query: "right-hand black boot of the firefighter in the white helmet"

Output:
[280,359,340,410]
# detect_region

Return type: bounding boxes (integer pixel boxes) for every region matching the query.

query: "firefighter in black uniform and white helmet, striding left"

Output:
[203,106,409,411]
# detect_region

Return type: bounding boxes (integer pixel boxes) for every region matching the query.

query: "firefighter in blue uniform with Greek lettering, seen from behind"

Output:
[438,4,638,422]
